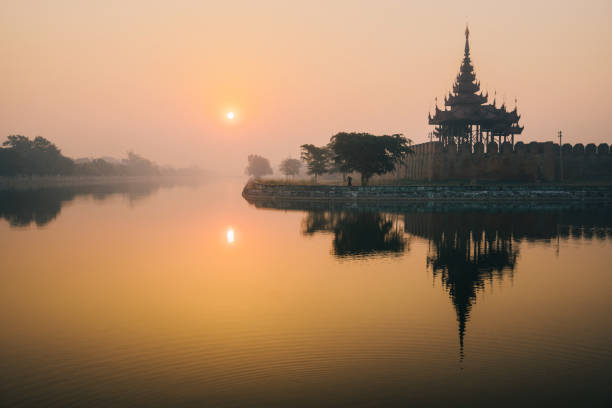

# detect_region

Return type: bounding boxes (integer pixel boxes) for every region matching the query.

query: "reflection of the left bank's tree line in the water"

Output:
[0,180,198,227]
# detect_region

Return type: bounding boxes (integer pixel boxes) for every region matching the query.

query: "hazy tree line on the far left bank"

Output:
[0,135,202,176]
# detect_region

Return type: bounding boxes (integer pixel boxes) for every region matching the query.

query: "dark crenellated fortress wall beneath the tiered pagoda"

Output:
[400,142,612,182]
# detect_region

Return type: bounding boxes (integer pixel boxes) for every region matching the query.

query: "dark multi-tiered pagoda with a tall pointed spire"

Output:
[428,27,523,146]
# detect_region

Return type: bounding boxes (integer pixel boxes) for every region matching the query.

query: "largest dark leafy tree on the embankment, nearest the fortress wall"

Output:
[329,132,413,186]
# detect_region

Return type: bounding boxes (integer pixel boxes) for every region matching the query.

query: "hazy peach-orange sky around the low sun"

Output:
[0,0,612,173]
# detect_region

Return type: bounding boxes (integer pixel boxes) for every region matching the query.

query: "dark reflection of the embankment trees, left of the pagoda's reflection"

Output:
[302,210,406,257]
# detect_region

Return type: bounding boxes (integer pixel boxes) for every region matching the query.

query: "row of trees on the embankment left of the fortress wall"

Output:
[246,132,414,186]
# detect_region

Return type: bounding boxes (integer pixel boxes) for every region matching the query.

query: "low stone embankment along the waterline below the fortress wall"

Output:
[242,181,612,202]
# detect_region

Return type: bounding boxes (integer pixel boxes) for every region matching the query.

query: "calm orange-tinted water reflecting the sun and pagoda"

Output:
[0,181,612,407]
